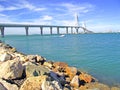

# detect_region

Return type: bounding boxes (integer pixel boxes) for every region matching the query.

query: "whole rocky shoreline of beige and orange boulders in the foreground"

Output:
[0,41,120,90]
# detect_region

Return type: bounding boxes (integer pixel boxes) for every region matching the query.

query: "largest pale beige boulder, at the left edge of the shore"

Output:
[0,60,23,79]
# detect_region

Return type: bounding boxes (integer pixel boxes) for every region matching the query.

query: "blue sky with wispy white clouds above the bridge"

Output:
[0,0,120,32]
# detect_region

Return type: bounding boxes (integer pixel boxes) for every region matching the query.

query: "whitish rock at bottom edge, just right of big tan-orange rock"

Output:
[42,80,63,90]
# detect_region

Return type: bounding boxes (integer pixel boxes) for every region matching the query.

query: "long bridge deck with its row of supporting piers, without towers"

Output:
[0,24,93,37]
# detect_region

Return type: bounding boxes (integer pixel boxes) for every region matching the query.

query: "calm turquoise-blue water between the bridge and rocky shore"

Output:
[0,34,120,85]
